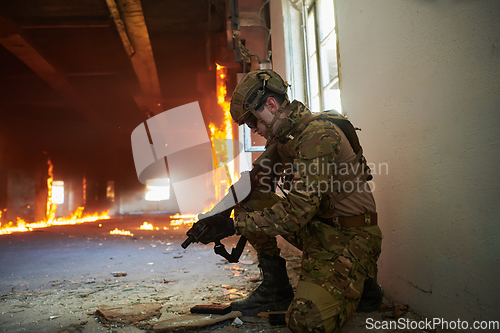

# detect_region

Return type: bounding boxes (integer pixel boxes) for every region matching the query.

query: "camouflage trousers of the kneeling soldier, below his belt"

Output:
[245,220,382,332]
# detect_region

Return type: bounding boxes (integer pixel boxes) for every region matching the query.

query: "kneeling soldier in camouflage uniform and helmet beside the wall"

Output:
[195,70,382,332]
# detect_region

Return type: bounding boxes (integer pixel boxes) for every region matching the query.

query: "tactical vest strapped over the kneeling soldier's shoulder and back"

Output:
[278,110,373,218]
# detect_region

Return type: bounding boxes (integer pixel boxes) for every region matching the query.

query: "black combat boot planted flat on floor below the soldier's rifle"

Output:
[231,254,293,316]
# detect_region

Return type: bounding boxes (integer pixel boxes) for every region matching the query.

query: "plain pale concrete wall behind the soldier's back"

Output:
[336,0,500,321]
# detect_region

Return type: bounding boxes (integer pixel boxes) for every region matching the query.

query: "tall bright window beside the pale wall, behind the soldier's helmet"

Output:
[306,0,342,112]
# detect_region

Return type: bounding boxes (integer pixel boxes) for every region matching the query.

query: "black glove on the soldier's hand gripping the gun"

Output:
[186,214,234,244]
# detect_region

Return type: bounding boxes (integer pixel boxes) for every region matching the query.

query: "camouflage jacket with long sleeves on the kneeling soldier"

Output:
[235,101,374,236]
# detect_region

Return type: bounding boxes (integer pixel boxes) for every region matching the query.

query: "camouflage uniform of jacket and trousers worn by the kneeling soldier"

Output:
[235,101,382,332]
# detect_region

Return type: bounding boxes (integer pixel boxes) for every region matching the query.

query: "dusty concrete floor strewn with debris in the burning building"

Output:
[0,215,452,333]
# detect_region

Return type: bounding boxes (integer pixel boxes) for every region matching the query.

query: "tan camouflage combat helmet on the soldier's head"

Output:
[230,69,289,125]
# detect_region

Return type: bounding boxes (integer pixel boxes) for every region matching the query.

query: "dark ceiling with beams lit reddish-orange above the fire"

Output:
[0,0,235,182]
